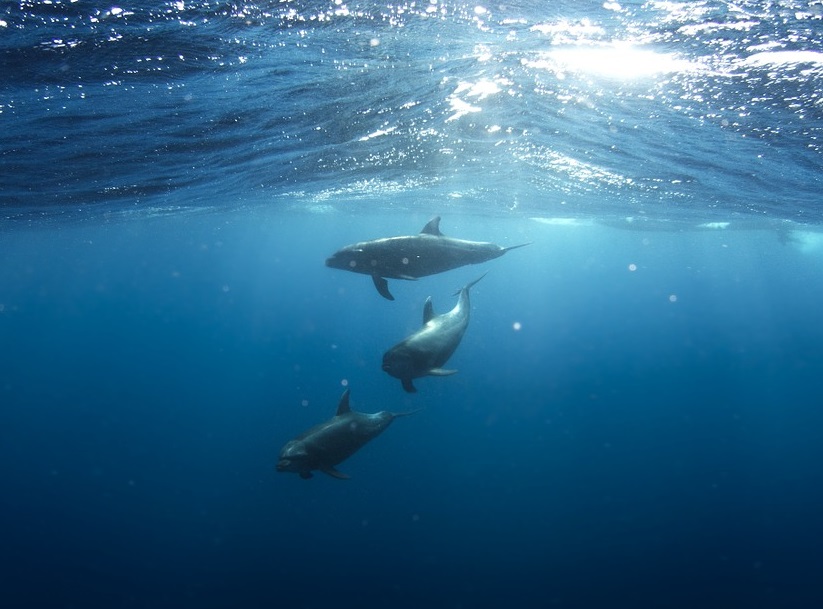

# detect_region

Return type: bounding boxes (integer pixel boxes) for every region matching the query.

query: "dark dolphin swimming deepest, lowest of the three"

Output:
[277,389,417,480]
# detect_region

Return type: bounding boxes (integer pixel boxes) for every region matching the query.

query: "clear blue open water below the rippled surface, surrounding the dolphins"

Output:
[0,208,823,608]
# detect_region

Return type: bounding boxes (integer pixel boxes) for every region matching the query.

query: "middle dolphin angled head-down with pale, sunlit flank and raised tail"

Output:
[383,274,485,393]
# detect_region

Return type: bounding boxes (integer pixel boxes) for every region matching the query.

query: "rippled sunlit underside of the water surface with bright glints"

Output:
[0,0,823,222]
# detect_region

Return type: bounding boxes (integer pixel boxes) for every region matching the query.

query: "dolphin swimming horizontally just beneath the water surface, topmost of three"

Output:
[326,216,529,300]
